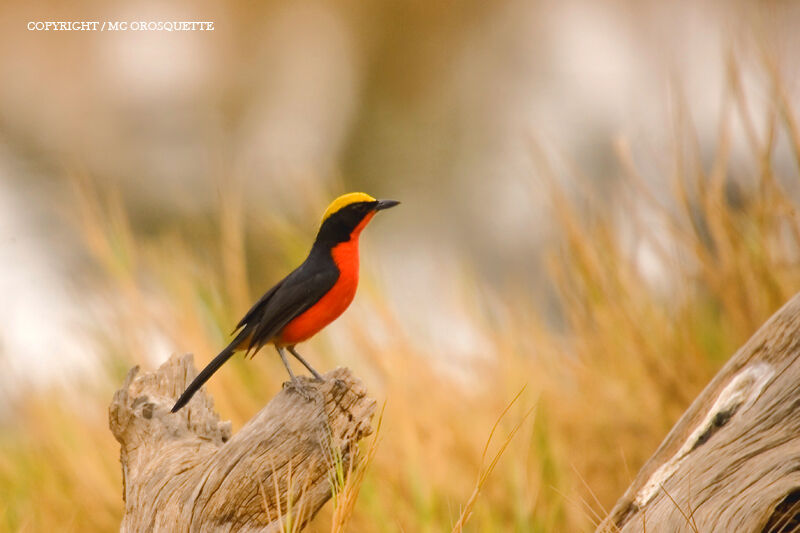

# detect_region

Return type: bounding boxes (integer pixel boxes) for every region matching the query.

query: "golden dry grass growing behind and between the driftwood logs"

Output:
[0,56,800,532]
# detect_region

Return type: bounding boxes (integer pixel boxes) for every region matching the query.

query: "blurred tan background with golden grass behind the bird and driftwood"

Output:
[0,0,800,531]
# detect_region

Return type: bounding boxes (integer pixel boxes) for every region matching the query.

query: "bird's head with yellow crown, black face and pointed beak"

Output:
[316,192,400,246]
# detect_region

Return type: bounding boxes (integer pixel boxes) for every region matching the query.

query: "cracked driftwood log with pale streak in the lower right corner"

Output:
[598,295,800,532]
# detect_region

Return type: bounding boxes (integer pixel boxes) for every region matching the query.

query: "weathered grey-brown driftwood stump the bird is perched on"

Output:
[109,355,375,532]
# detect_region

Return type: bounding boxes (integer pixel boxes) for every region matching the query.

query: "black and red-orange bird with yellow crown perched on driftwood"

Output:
[172,192,400,413]
